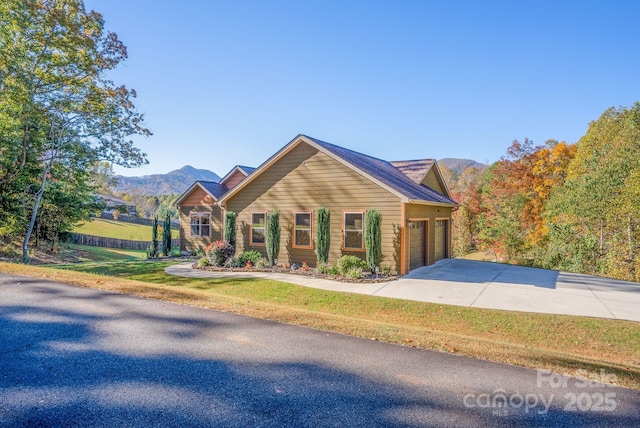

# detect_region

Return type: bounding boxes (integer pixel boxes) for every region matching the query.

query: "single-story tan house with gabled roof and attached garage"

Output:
[176,135,456,274]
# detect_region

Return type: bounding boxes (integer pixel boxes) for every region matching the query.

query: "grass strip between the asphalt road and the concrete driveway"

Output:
[0,262,640,389]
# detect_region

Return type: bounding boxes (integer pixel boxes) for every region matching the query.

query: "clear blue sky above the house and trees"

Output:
[86,0,640,175]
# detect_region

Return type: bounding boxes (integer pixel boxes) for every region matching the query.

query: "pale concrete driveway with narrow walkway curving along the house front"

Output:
[165,259,640,321]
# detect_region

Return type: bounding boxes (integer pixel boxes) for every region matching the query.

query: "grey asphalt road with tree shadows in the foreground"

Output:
[0,274,640,427]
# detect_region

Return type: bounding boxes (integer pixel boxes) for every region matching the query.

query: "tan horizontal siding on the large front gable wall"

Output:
[227,143,400,266]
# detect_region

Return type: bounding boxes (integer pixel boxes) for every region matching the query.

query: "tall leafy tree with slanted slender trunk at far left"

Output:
[0,0,150,261]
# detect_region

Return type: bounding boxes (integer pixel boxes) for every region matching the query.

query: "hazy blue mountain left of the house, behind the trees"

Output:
[113,165,220,196]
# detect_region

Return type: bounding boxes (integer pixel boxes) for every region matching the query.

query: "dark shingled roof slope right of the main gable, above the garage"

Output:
[304,135,456,205]
